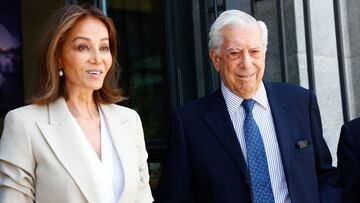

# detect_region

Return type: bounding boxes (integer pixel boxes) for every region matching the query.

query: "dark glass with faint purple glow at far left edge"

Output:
[0,0,24,118]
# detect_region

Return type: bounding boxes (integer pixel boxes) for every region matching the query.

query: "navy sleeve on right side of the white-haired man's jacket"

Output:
[310,93,341,203]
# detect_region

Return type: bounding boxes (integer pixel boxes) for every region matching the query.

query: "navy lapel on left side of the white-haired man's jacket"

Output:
[205,89,248,179]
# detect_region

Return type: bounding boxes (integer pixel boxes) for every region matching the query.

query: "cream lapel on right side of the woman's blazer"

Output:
[100,105,138,202]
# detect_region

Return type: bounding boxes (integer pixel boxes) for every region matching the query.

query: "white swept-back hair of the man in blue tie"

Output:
[209,10,268,53]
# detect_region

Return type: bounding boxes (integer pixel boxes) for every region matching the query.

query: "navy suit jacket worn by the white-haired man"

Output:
[156,82,341,203]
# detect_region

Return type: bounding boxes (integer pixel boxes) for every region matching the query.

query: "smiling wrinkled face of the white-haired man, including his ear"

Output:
[210,24,266,99]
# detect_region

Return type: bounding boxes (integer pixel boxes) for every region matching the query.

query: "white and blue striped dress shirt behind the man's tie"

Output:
[221,82,291,203]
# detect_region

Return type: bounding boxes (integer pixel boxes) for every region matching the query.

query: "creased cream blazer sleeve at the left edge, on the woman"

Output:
[0,111,36,203]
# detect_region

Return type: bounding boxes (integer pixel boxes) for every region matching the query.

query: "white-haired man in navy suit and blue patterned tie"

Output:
[157,10,340,203]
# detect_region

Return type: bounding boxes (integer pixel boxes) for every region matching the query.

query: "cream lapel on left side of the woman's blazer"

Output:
[37,98,102,203]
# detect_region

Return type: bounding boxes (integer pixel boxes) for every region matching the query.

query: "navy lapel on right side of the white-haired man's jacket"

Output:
[264,82,293,182]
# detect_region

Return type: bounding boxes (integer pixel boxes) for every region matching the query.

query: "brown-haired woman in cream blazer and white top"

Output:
[0,5,153,203]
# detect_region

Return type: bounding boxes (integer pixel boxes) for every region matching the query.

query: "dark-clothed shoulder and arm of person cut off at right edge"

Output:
[337,118,360,203]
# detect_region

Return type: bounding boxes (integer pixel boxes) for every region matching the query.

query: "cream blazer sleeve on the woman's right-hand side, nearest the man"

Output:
[135,114,154,203]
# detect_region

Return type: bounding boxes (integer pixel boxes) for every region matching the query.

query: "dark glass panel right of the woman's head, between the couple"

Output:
[108,0,170,189]
